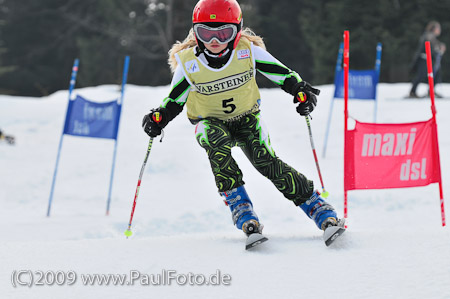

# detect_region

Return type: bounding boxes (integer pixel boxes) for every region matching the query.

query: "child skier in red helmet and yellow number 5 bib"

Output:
[142,0,342,245]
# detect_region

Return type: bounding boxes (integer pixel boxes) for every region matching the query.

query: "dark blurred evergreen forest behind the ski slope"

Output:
[0,0,450,96]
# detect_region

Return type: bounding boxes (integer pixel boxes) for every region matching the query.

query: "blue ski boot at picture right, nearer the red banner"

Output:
[300,191,338,230]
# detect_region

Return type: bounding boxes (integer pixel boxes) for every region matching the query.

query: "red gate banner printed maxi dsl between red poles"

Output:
[344,118,441,190]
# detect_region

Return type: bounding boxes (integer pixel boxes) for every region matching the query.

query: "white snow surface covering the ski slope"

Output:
[0,83,450,299]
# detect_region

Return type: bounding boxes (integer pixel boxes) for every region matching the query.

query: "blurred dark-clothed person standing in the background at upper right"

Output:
[409,21,446,98]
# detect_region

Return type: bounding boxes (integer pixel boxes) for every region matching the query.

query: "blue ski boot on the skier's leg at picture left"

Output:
[220,186,262,236]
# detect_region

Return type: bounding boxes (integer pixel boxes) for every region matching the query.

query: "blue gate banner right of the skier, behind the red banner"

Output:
[334,70,378,100]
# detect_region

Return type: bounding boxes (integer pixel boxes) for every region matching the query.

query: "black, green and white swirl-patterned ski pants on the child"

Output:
[195,112,313,205]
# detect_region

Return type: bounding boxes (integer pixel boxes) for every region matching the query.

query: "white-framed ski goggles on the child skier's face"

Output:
[194,24,237,44]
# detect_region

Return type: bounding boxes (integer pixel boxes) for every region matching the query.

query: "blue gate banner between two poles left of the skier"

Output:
[63,95,121,140]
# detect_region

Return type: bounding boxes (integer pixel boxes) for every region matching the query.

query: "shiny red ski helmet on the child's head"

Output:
[192,0,242,49]
